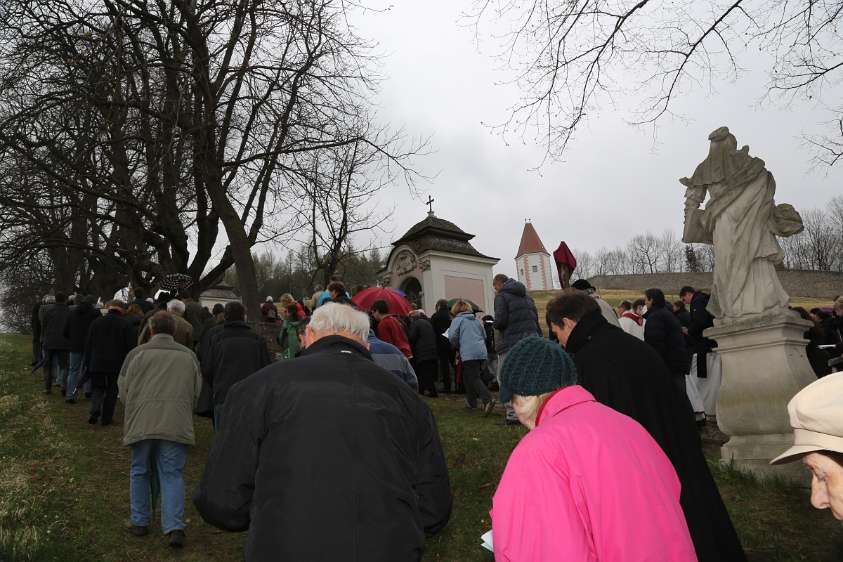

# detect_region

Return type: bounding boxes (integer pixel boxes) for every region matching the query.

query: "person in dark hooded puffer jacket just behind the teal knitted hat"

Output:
[492,273,542,425]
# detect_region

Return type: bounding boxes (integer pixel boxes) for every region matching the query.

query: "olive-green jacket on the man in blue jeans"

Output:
[117,334,202,445]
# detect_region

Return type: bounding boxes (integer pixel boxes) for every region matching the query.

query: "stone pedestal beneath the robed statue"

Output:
[705,310,816,482]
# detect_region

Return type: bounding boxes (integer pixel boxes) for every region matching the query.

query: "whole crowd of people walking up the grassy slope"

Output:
[24,275,843,561]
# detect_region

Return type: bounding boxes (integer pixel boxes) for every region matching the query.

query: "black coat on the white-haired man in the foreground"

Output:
[194,336,451,562]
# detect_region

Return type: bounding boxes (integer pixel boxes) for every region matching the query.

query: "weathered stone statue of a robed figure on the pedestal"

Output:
[679,127,803,325]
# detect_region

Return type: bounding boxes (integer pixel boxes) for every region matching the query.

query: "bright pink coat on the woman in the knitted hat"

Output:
[491,386,697,562]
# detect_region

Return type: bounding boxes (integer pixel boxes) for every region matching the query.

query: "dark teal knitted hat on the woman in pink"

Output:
[500,336,577,403]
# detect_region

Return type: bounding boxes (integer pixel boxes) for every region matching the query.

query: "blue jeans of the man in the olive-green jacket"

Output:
[129,439,187,534]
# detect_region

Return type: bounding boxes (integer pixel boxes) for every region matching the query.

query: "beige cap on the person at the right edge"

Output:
[770,373,843,464]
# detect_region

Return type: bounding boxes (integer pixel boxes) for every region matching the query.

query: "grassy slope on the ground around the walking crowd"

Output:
[0,336,843,562]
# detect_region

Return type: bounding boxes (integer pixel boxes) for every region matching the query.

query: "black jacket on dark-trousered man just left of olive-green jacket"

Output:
[85,310,136,374]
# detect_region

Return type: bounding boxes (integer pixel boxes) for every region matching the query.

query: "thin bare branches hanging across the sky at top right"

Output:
[470,0,843,164]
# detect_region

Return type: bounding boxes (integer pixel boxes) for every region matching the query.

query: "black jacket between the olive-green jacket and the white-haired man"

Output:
[202,322,270,405]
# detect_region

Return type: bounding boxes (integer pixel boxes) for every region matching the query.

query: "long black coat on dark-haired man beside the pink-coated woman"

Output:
[566,312,746,562]
